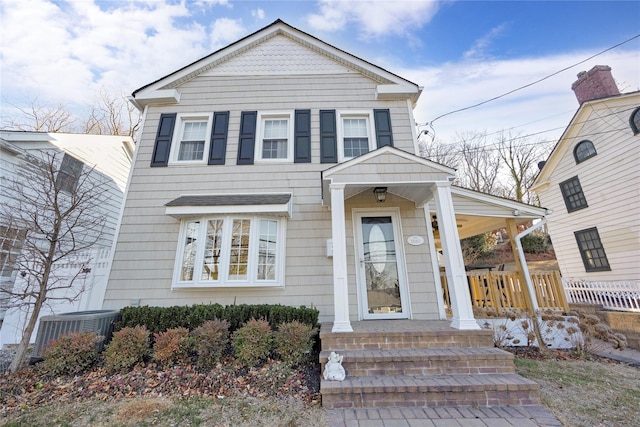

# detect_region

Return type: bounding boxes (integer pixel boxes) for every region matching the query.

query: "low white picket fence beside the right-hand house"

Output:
[562,278,640,312]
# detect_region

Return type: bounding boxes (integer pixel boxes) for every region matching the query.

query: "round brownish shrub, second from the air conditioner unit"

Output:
[104,325,149,372]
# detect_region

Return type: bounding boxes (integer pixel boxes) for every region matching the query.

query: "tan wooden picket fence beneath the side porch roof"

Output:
[440,270,569,313]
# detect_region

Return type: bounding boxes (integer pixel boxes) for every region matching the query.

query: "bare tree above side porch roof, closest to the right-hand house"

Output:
[496,132,549,204]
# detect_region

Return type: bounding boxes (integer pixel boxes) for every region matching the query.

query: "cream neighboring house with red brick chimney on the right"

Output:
[533,65,640,286]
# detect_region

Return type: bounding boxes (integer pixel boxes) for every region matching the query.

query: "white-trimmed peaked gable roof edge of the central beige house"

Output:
[130,19,422,110]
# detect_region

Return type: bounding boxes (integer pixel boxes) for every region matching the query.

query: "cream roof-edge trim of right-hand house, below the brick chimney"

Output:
[532,91,640,187]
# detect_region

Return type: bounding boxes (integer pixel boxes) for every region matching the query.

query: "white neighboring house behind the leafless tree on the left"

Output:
[0,131,134,348]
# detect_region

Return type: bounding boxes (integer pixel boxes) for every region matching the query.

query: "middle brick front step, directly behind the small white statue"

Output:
[320,347,515,377]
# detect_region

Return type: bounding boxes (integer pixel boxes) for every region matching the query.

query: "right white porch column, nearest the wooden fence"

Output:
[435,182,480,329]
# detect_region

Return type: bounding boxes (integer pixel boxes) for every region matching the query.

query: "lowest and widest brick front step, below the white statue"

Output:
[321,374,540,408]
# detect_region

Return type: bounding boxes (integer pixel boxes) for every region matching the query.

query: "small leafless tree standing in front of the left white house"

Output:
[0,153,109,372]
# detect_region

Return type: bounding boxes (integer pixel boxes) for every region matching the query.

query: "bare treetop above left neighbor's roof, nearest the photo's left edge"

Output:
[3,98,75,132]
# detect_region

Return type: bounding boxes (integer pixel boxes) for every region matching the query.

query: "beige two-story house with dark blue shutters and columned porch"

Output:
[103,20,546,331]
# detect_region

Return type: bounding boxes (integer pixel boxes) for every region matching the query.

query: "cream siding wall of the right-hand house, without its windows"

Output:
[538,94,640,281]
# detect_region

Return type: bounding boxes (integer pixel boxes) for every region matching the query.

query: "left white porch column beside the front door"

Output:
[329,184,353,332]
